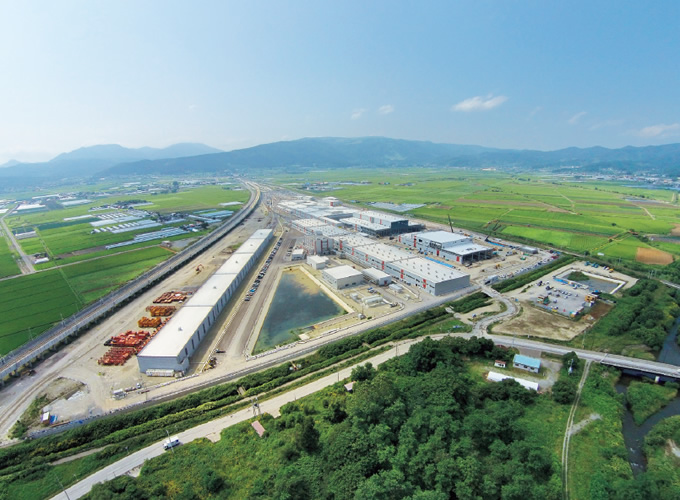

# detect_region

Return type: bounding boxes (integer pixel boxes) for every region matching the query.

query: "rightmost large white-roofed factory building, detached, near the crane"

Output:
[399,231,493,264]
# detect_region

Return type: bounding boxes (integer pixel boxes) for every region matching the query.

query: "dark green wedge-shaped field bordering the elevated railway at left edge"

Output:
[0,247,172,355]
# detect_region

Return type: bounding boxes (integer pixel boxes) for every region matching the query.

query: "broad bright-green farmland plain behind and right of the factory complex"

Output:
[278,168,680,261]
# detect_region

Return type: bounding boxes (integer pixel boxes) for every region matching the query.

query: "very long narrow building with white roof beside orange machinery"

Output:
[137,229,273,373]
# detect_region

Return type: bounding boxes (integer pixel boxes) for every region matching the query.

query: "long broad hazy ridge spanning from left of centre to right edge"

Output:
[98,137,680,176]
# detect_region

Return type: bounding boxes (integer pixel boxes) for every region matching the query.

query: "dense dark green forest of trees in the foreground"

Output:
[85,338,561,500]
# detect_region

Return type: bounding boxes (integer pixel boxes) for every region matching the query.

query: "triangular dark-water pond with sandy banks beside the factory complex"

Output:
[253,271,345,353]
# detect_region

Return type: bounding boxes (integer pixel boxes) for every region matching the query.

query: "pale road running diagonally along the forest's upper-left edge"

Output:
[53,341,414,500]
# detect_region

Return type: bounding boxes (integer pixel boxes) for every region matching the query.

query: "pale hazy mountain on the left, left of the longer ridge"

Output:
[0,143,222,186]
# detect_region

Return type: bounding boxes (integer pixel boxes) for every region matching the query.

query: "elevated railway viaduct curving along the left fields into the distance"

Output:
[0,183,261,381]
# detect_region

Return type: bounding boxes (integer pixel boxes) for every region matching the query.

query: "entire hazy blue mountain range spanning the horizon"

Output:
[0,137,680,189]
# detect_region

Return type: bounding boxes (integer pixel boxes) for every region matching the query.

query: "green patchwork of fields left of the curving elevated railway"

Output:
[0,186,250,355]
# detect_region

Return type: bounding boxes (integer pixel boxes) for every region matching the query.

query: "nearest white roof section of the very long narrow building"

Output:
[139,306,212,358]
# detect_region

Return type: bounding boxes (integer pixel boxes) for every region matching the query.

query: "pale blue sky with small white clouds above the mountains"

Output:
[0,0,680,164]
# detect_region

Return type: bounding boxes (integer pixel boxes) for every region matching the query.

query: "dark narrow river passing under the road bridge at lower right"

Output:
[616,318,680,475]
